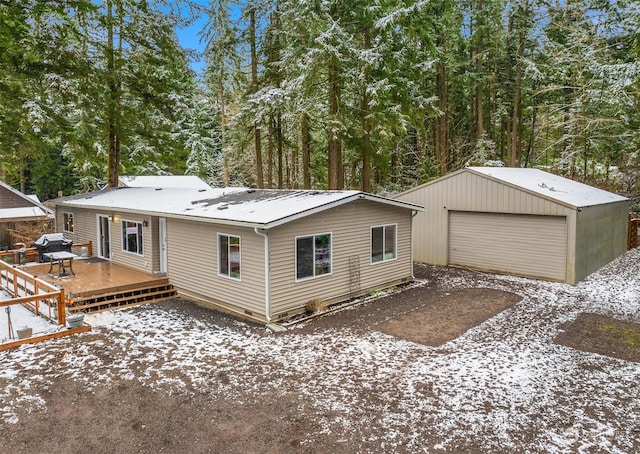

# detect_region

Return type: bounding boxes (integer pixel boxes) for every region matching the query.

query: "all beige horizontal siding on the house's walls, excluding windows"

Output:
[59,200,412,319]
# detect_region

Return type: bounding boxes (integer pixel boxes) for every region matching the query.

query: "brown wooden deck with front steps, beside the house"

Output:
[23,257,176,312]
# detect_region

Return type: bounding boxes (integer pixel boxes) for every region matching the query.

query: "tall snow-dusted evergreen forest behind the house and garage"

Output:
[0,0,640,206]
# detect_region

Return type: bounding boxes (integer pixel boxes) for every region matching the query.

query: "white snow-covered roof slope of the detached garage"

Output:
[467,167,627,208]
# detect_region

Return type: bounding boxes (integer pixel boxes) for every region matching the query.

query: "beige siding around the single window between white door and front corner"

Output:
[167,218,265,316]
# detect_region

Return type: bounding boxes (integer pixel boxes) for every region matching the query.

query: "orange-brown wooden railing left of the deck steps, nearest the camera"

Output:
[0,260,66,325]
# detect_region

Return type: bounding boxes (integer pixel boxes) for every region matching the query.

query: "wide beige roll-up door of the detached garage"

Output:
[449,211,567,281]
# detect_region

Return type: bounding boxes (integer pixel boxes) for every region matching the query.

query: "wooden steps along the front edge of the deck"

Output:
[69,279,177,313]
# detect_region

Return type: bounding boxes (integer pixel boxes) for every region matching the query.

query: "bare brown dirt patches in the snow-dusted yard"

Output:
[0,267,638,454]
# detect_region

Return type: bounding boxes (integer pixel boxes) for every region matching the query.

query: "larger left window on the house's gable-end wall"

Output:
[296,233,331,280]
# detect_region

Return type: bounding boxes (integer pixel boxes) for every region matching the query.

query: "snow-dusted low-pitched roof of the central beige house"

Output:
[54,188,423,229]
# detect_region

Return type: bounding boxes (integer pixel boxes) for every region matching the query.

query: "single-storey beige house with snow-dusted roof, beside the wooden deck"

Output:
[53,187,422,322]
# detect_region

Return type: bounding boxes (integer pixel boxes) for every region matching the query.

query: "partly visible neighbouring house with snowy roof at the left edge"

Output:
[0,181,53,250]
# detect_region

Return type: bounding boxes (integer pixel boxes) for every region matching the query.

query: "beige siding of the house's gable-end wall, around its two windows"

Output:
[269,200,412,318]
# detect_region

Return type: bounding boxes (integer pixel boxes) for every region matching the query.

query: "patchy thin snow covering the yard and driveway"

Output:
[0,249,640,453]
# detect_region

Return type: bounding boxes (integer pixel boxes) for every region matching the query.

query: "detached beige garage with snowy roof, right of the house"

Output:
[396,167,629,284]
